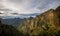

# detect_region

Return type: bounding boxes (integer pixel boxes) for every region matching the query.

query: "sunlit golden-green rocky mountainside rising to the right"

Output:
[18,6,60,36]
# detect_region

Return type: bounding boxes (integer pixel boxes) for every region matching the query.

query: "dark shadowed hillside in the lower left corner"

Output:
[0,19,22,36]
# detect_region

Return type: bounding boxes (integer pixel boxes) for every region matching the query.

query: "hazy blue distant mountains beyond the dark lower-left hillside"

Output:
[1,18,25,27]
